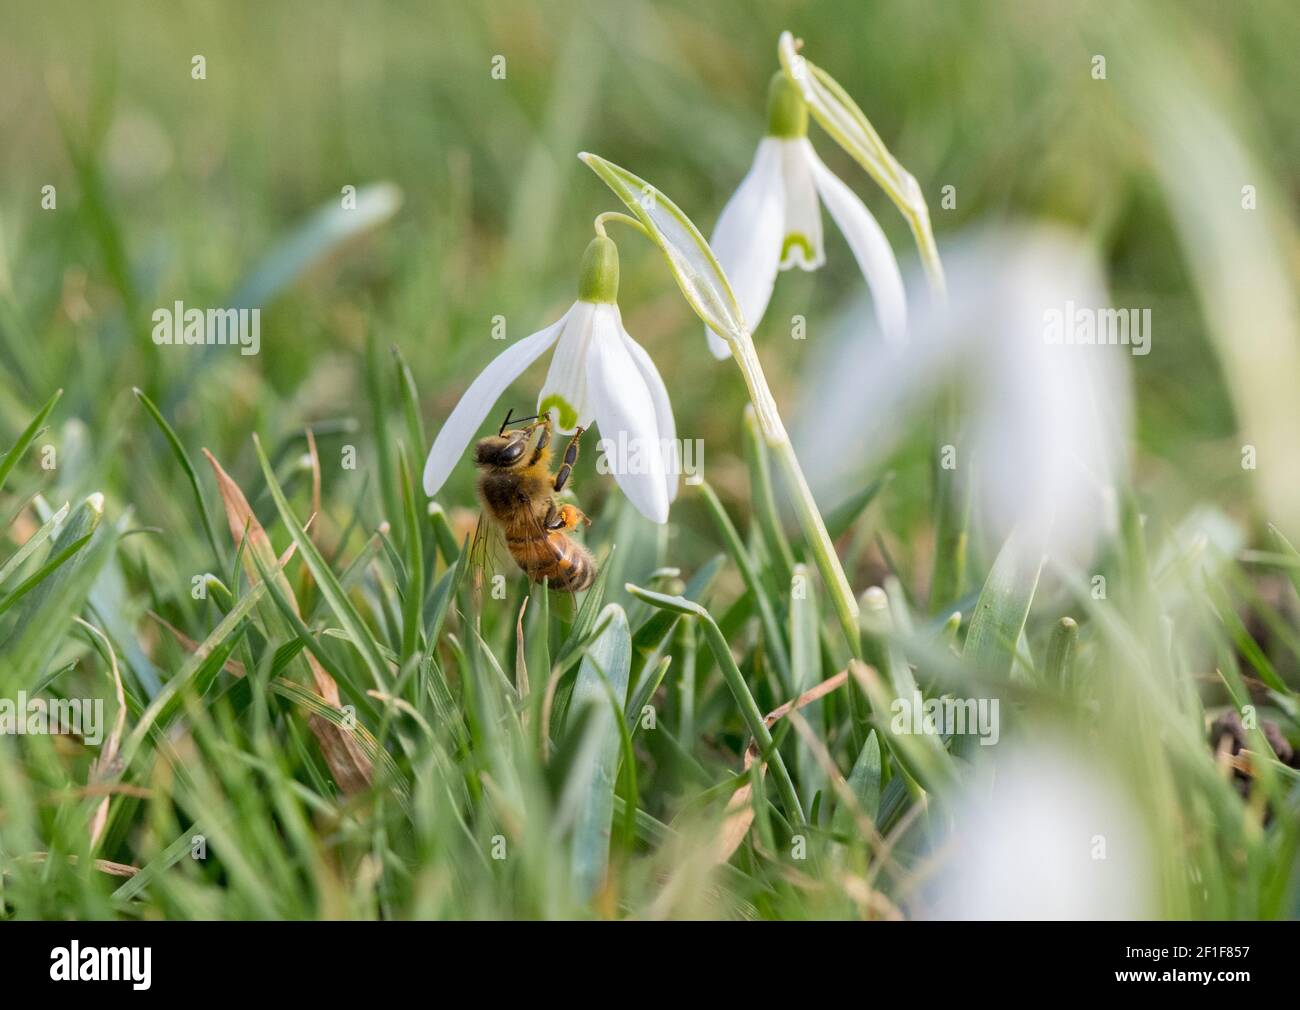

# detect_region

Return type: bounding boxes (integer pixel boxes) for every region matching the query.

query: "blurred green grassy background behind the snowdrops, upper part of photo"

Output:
[0,0,1300,572]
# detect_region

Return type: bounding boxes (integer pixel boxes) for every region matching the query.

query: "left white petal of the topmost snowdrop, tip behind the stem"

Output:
[705,136,785,359]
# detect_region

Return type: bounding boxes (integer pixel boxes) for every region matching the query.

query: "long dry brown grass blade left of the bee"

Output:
[203,448,373,796]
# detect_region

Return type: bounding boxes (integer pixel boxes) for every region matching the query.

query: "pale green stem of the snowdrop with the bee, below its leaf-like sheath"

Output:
[731,324,862,659]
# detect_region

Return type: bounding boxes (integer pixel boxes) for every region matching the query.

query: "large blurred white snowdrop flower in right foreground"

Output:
[794,227,1132,564]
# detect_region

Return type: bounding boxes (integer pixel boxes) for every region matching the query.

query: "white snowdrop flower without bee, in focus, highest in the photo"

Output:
[706,71,907,359]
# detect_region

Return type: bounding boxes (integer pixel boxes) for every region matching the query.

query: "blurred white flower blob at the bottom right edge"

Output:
[926,744,1156,920]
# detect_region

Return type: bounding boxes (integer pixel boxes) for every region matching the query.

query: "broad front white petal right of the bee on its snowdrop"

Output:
[586,305,668,523]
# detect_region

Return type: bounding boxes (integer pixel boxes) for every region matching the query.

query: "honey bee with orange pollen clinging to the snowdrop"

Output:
[475,412,597,593]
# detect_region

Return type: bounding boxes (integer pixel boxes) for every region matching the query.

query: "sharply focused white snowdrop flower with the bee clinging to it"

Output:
[424,235,677,523]
